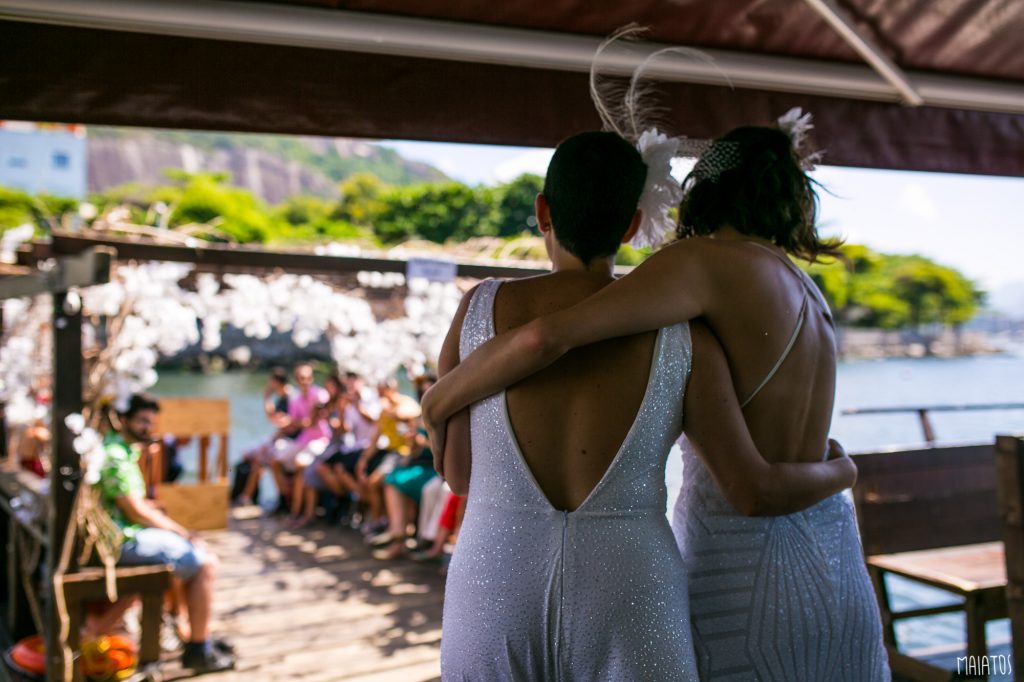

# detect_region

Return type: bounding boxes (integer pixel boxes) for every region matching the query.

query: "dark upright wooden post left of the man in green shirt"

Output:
[46,292,82,680]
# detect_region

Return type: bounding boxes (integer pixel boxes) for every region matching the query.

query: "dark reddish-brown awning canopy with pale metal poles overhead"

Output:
[0,0,1024,175]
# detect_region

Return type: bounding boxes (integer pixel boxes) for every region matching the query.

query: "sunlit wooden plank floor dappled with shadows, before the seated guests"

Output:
[163,509,444,682]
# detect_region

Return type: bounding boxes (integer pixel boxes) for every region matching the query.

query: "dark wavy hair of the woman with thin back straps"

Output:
[676,126,843,262]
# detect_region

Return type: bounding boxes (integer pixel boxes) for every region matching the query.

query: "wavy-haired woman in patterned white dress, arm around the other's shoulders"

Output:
[424,119,889,682]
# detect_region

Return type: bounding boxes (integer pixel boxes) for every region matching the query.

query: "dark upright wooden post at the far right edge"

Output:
[995,436,1024,679]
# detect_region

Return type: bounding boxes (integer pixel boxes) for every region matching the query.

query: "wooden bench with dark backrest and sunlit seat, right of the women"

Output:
[854,445,1007,680]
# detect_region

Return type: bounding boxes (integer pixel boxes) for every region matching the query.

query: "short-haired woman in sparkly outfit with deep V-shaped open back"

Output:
[440,133,854,682]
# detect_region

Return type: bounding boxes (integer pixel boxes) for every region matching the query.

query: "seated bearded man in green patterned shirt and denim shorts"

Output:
[99,393,234,673]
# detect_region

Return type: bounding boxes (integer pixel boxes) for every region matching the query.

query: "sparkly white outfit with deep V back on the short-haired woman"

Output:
[441,281,697,682]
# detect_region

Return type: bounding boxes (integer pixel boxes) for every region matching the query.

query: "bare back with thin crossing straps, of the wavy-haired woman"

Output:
[700,239,837,462]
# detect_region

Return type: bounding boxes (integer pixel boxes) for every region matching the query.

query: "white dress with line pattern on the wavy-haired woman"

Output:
[673,438,891,682]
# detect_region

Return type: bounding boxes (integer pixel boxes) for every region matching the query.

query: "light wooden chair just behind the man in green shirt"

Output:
[146,398,231,530]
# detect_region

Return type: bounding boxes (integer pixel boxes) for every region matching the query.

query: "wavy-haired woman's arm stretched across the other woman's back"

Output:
[423,242,710,446]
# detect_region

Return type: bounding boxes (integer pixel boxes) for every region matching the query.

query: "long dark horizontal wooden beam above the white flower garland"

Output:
[39,232,551,278]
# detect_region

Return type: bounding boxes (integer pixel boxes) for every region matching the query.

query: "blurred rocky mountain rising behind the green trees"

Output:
[88,126,446,204]
